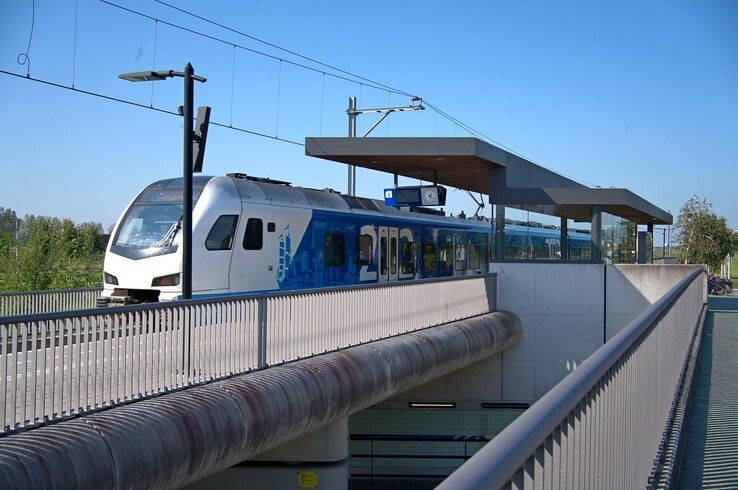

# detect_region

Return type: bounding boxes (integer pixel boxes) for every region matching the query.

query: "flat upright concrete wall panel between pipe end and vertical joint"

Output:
[491,263,605,401]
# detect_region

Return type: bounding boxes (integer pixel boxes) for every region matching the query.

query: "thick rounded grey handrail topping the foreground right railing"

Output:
[437,269,704,489]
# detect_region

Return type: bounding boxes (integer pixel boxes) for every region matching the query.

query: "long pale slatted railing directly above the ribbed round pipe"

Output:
[0,274,496,434]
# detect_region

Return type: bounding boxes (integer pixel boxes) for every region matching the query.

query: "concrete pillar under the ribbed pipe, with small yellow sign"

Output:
[187,418,349,490]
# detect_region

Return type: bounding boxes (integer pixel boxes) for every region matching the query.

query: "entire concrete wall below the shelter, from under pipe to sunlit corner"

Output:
[386,263,699,410]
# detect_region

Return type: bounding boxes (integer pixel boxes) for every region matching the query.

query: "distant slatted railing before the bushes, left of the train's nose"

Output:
[0,288,102,317]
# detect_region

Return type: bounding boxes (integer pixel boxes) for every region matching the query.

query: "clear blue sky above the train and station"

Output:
[0,0,738,236]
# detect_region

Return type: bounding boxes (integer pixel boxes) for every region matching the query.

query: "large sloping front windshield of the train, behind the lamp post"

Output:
[110,176,211,259]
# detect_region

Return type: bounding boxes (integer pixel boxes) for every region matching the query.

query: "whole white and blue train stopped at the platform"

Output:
[102,174,590,304]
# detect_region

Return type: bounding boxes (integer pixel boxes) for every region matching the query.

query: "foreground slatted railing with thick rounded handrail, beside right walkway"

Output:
[438,269,705,489]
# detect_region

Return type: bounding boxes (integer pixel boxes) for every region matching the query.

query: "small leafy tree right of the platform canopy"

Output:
[675,196,733,270]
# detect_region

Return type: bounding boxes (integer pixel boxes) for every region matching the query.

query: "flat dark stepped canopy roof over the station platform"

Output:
[305,137,673,224]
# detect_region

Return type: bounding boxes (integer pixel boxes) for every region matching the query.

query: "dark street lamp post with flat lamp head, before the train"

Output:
[118,63,206,299]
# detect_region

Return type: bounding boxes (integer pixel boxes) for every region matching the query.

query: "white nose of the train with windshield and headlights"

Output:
[98,175,212,306]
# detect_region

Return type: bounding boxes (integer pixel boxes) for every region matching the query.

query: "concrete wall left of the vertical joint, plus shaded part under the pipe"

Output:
[378,263,605,409]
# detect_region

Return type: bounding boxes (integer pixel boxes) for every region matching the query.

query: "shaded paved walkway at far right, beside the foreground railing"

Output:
[679,294,738,489]
